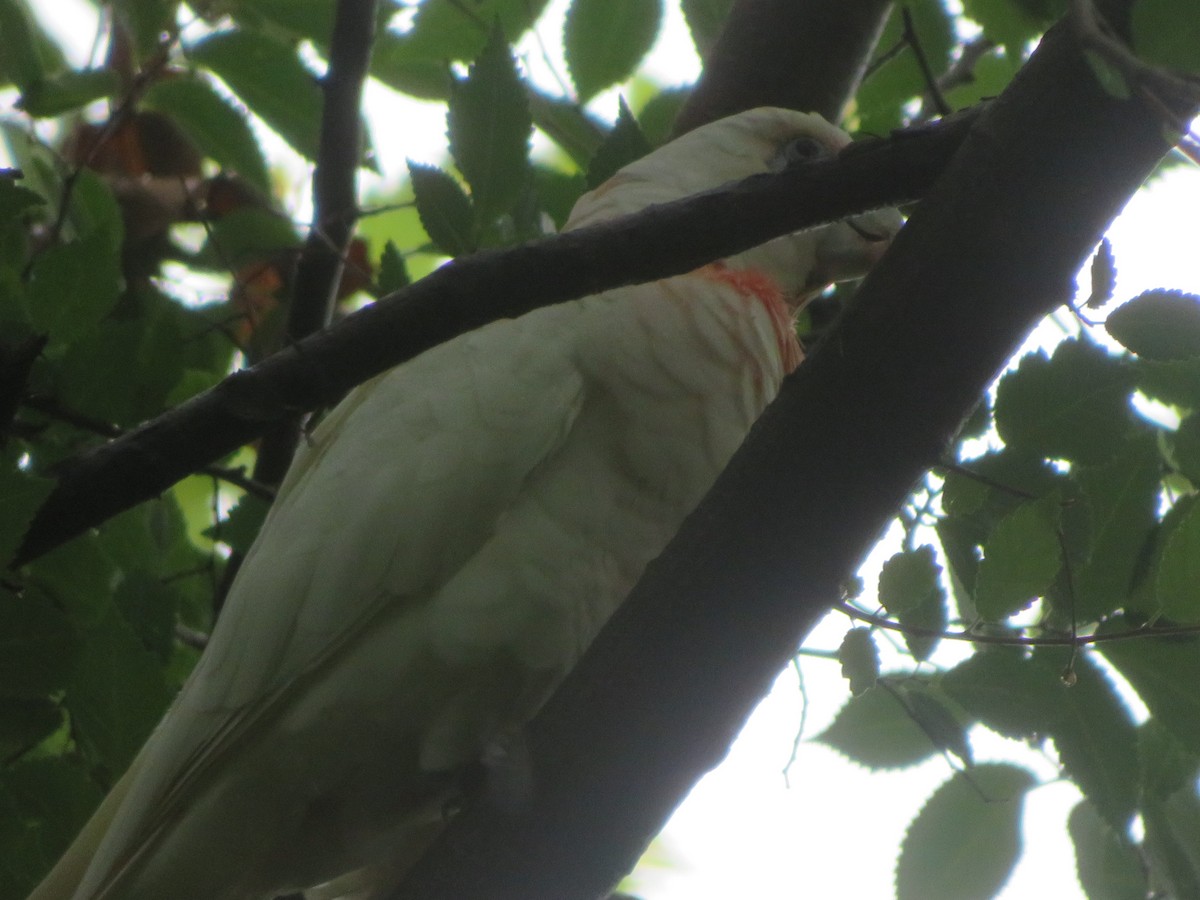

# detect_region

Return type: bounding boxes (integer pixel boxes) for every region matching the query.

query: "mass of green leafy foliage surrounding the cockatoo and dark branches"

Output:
[7,0,1200,900]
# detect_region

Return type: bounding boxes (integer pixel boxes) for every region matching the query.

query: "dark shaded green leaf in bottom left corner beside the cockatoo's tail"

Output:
[0,758,101,898]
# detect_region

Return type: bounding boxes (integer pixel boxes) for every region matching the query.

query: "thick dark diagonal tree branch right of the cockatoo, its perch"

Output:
[392,8,1195,900]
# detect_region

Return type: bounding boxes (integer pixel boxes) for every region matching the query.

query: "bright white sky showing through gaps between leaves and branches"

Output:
[23,0,1200,900]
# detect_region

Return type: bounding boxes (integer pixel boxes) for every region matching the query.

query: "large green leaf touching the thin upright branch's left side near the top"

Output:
[187,31,321,160]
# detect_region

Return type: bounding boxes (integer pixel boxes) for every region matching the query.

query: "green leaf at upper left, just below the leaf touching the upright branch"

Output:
[143,78,271,193]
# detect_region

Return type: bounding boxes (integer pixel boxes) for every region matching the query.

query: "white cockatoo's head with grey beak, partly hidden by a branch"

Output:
[566,107,902,308]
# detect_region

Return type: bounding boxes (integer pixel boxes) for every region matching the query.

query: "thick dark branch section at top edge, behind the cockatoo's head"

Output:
[674,0,892,134]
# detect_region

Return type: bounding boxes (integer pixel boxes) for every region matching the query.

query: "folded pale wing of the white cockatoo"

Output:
[75,305,583,900]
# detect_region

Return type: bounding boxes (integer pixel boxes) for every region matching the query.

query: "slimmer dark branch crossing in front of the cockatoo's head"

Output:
[14,116,970,565]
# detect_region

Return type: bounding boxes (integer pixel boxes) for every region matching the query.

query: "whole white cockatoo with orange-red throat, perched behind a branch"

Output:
[32,108,900,900]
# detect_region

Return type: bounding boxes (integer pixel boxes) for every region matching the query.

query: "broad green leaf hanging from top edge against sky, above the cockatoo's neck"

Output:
[563,0,662,102]
